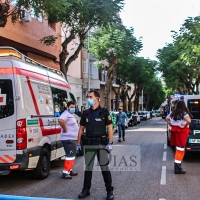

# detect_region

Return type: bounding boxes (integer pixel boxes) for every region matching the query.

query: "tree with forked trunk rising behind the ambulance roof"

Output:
[41,0,124,75]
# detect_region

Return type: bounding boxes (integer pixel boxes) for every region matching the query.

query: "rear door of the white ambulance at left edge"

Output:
[0,59,17,166]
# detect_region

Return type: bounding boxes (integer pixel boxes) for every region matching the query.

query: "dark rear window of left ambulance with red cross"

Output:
[0,79,14,119]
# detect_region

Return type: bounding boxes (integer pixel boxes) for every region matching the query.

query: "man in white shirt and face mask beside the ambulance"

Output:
[58,101,79,179]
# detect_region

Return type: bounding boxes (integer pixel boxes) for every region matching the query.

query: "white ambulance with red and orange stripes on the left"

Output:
[0,47,79,179]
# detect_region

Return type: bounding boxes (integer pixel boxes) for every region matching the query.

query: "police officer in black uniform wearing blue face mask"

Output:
[77,90,114,200]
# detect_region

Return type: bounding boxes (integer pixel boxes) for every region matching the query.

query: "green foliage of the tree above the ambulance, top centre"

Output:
[47,0,124,34]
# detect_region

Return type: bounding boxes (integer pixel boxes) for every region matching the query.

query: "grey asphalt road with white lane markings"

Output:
[0,117,200,200]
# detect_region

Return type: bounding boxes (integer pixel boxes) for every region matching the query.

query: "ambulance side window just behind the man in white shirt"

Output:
[51,87,68,117]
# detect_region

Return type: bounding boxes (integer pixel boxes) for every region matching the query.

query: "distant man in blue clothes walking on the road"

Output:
[117,107,129,142]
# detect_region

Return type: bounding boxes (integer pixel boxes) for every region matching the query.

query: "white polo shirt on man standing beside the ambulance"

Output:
[59,110,79,140]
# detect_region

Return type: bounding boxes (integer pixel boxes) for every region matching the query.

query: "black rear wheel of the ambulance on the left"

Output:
[34,148,50,179]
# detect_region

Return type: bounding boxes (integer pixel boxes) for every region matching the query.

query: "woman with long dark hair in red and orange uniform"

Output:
[165,101,192,174]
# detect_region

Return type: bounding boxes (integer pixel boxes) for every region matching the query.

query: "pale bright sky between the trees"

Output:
[120,0,200,60]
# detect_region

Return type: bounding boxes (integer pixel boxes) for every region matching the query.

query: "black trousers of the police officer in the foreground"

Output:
[83,141,114,191]
